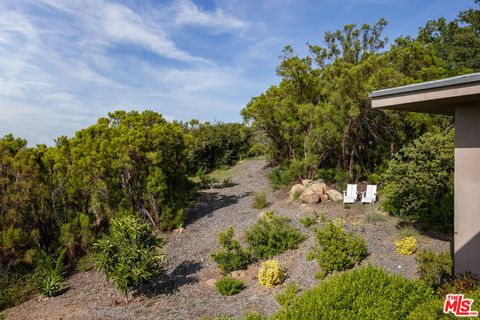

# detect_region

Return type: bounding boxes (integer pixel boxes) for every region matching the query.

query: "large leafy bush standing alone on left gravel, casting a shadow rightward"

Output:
[95,214,165,302]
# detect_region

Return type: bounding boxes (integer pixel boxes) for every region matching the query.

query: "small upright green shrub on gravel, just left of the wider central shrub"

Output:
[211,227,251,273]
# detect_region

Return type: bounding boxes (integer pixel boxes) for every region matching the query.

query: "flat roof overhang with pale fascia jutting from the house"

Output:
[369,73,480,115]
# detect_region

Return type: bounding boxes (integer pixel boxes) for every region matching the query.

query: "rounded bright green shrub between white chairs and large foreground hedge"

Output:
[307,221,367,278]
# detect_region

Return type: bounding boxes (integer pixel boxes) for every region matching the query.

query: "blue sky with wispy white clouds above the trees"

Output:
[0,0,474,145]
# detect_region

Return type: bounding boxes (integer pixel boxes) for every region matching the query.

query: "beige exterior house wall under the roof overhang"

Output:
[454,102,480,276]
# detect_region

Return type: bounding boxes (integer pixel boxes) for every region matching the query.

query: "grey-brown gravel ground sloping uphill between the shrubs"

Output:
[6,160,450,319]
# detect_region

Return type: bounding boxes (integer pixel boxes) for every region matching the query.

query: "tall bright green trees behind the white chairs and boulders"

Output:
[242,19,450,185]
